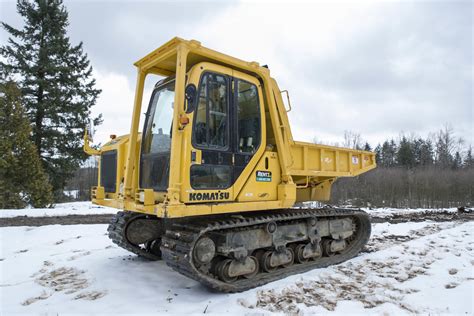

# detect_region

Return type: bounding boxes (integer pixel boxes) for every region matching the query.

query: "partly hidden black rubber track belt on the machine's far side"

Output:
[107,211,161,260]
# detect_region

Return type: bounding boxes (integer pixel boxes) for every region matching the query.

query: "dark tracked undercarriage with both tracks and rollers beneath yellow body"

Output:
[108,207,370,292]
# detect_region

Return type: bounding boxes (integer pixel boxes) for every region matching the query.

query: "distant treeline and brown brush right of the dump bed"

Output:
[331,126,474,208]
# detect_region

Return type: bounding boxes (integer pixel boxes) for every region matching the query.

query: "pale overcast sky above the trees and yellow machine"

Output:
[0,0,474,145]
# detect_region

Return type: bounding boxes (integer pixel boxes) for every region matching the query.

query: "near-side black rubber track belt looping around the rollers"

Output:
[161,208,371,293]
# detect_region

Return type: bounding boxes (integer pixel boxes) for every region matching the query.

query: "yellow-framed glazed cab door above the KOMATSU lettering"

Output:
[184,63,265,203]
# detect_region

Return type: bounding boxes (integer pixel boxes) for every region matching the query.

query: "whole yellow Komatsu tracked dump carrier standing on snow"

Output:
[84,38,376,292]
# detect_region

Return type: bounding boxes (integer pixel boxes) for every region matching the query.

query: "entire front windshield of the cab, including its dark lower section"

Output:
[140,80,175,191]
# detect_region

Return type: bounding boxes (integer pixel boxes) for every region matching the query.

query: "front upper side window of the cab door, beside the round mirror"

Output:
[193,73,229,149]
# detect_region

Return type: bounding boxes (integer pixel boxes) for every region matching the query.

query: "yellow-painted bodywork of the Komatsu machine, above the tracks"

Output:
[84,38,376,218]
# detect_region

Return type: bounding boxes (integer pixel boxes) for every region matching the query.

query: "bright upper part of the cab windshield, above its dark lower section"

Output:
[142,81,174,154]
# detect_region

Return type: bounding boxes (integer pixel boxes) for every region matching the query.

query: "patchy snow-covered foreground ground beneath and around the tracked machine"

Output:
[0,220,474,315]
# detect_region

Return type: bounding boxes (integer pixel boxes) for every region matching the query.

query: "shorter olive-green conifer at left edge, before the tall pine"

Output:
[0,81,52,208]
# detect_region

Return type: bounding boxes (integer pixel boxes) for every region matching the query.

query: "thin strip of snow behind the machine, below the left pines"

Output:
[0,202,117,218]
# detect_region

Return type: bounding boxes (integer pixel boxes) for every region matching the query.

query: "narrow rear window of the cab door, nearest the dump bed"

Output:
[236,80,260,153]
